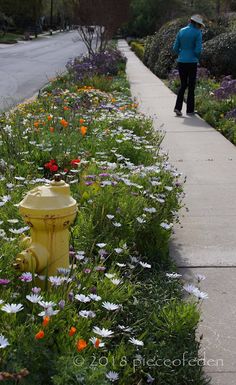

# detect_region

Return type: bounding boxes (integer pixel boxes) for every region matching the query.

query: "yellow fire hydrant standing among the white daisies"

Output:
[14,175,78,276]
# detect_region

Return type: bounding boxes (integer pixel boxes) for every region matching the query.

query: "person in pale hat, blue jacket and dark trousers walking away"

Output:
[173,15,204,116]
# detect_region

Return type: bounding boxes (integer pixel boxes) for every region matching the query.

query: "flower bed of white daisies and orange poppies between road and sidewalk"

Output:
[0,49,207,385]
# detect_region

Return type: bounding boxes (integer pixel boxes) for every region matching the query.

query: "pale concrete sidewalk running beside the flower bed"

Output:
[119,40,236,385]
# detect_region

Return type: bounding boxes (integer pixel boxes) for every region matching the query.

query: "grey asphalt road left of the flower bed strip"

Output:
[0,31,86,111]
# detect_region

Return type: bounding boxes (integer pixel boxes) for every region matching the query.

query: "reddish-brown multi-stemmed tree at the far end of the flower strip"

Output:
[75,0,130,55]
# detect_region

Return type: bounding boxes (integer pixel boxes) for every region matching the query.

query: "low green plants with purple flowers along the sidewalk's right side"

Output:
[168,68,236,144]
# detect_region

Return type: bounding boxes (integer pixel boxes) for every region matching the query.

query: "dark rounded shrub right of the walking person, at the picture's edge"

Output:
[201,32,236,77]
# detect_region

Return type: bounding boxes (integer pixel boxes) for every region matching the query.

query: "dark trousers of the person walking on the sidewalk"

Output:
[175,63,197,113]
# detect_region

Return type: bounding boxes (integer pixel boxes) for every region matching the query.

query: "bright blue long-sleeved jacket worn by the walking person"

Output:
[173,23,202,63]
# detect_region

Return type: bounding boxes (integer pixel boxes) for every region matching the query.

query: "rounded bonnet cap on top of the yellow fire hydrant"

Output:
[19,181,77,215]
